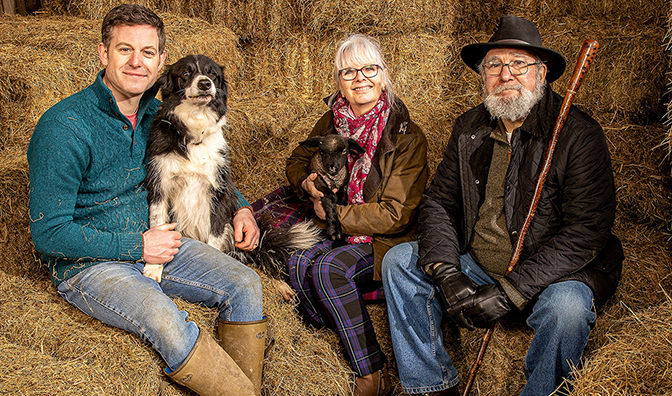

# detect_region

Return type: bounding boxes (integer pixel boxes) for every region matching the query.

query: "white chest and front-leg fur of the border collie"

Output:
[150,103,229,241]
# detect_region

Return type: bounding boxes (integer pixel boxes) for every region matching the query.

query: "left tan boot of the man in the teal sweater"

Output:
[166,330,254,396]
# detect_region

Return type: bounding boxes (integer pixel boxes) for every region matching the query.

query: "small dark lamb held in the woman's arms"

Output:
[299,134,364,244]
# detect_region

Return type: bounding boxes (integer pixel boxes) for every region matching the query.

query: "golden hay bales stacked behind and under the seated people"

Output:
[0,0,672,396]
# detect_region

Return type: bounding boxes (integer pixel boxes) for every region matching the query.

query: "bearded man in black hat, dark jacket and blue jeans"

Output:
[383,16,623,396]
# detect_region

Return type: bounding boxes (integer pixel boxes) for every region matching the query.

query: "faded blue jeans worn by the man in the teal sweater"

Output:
[58,238,263,371]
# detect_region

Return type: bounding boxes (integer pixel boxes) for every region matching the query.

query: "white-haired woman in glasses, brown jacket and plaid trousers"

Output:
[286,34,428,396]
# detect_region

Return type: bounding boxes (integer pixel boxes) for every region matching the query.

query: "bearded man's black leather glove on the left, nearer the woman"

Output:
[432,264,477,330]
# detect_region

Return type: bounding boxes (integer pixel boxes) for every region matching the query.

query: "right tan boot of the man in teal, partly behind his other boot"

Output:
[217,318,268,396]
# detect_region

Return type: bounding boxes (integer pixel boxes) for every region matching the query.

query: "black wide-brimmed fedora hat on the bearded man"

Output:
[460,15,566,83]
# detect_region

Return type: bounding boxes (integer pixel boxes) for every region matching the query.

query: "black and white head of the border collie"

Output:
[157,55,229,115]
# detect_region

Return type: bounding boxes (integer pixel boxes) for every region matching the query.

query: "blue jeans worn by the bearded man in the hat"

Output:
[383,242,596,396]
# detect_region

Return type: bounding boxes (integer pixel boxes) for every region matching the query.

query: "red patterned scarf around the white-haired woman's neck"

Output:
[332,91,390,243]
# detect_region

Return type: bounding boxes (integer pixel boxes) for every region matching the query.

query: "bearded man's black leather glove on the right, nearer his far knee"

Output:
[448,284,513,328]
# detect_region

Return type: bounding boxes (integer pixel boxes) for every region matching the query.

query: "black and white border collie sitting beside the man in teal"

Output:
[143,55,319,299]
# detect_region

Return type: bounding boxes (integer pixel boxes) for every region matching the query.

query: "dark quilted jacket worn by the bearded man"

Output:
[418,86,623,304]
